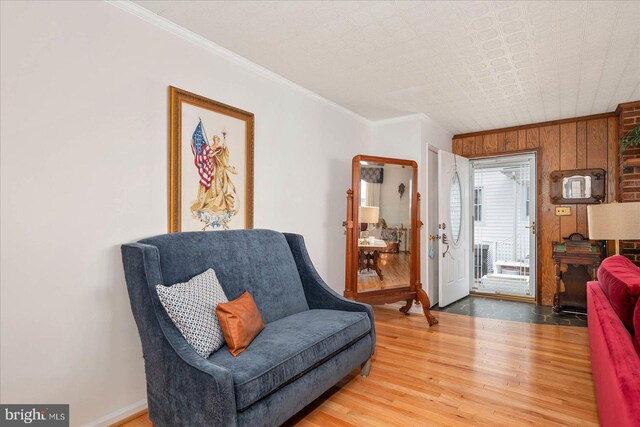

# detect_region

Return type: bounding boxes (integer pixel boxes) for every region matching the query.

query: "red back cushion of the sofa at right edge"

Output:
[598,255,640,331]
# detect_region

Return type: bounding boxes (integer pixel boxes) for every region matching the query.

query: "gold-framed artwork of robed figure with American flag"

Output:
[169,86,253,233]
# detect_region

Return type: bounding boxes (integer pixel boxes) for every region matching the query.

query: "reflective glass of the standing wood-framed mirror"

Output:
[358,161,413,292]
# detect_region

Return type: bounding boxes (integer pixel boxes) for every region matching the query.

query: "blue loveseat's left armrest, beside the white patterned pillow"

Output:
[121,243,236,426]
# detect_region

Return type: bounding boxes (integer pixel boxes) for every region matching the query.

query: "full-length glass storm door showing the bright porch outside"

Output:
[471,154,536,300]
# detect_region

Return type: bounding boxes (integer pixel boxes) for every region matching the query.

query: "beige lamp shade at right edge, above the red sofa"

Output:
[587,202,640,240]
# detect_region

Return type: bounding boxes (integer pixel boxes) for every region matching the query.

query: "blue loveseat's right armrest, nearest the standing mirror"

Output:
[284,233,376,354]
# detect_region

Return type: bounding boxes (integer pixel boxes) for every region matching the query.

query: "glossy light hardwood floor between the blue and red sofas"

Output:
[125,308,598,427]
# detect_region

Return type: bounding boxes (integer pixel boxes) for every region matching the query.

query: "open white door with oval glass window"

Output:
[438,150,471,307]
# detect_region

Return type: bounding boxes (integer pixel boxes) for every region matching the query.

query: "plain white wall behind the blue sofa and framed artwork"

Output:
[0,2,451,425]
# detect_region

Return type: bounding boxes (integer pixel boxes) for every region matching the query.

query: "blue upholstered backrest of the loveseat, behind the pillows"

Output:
[140,230,309,323]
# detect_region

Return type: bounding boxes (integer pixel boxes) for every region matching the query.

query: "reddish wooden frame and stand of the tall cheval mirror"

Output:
[344,155,438,326]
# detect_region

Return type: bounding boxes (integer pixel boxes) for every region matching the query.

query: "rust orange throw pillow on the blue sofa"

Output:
[216,292,264,356]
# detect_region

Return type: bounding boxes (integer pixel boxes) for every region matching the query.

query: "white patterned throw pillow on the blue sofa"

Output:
[156,268,229,358]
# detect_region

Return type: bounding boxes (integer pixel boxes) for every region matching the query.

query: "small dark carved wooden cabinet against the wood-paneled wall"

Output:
[553,233,605,313]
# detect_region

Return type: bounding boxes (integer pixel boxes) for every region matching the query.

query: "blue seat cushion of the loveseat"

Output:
[208,310,371,411]
